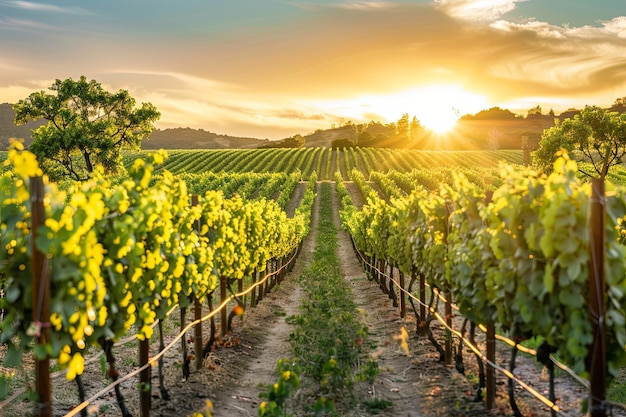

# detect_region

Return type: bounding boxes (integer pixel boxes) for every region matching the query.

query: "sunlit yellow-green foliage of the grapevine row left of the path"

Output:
[0,144,312,379]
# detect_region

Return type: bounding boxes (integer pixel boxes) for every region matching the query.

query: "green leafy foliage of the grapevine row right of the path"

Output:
[340,156,626,410]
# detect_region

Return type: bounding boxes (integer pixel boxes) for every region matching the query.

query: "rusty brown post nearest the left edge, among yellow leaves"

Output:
[30,177,52,417]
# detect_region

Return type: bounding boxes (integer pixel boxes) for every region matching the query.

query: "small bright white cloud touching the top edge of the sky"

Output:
[435,0,527,22]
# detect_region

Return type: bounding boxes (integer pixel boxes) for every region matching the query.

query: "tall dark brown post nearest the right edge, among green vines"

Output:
[587,178,606,417]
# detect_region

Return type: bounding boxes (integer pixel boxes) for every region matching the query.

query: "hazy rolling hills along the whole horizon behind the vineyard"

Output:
[0,103,624,150]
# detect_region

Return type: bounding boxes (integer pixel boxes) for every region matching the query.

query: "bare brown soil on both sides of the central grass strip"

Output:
[2,183,624,417]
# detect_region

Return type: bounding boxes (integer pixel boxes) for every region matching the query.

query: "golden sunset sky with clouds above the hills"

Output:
[0,0,626,139]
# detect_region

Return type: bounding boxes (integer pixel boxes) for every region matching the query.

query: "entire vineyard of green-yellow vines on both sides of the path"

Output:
[0,146,626,417]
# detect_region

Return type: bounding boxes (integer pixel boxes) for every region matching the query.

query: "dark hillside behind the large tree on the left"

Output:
[0,103,269,150]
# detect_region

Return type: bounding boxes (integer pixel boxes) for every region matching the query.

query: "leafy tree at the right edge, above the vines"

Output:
[533,106,626,180]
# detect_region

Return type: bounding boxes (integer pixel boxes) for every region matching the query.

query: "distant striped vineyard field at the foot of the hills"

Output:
[120,148,523,181]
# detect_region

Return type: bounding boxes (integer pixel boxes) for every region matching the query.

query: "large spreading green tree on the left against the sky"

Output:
[13,76,161,181]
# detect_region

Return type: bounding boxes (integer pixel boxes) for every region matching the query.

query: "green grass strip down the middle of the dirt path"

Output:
[263,183,372,416]
